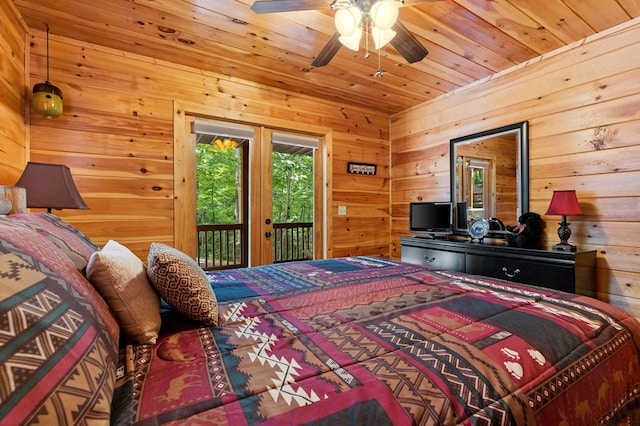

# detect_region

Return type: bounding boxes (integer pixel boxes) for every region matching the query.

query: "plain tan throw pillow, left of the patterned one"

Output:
[87,240,160,344]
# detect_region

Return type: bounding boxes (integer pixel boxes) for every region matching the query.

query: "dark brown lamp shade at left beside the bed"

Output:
[15,162,89,211]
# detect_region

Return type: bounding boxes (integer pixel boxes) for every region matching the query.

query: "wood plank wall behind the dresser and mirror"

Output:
[391,19,640,317]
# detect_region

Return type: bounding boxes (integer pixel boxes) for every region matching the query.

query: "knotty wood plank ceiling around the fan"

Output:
[13,0,640,114]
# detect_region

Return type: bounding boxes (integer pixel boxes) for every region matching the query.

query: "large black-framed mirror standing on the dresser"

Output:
[450,121,529,238]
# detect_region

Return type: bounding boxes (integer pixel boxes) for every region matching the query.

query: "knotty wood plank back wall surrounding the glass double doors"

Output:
[0,5,390,259]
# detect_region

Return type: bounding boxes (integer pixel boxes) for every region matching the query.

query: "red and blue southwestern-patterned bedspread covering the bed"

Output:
[114,257,640,426]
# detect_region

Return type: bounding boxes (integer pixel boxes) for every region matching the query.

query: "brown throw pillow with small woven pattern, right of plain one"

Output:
[147,243,218,325]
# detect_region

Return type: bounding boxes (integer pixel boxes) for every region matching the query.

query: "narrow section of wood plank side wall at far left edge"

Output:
[0,2,28,181]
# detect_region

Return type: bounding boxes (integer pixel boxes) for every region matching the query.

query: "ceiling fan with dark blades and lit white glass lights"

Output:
[251,0,439,67]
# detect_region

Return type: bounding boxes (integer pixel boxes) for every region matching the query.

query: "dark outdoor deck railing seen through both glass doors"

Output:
[197,222,313,270]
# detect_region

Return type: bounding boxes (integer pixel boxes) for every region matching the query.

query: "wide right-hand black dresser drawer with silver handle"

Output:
[466,254,575,293]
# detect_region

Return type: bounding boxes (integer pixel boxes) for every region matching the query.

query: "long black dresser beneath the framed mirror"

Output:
[400,237,596,296]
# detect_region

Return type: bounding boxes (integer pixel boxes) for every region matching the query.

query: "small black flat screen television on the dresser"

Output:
[409,201,453,237]
